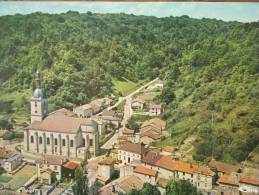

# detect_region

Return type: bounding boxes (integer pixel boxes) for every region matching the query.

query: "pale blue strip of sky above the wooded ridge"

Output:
[0,2,259,22]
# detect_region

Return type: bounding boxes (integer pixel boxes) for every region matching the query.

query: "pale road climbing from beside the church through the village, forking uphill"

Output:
[101,78,158,149]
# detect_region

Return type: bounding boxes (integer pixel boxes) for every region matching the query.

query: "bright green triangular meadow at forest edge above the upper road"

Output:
[112,78,144,96]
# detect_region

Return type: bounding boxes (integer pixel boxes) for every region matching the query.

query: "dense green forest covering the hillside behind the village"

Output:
[0,11,259,163]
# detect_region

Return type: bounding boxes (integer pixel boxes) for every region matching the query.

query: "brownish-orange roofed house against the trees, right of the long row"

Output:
[208,159,241,177]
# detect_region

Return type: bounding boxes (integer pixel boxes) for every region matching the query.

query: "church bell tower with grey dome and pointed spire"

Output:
[31,71,48,123]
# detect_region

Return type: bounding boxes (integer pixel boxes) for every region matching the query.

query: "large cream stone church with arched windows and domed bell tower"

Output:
[23,71,99,159]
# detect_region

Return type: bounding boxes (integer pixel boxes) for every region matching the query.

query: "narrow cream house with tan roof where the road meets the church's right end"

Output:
[97,157,115,184]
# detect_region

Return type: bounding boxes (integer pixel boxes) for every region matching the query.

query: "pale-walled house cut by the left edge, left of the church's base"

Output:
[0,148,22,172]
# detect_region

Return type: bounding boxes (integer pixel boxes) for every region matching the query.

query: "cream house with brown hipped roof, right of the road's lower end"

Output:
[118,142,148,164]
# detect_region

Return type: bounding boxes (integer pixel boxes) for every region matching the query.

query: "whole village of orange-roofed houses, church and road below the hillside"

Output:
[0,72,259,195]
